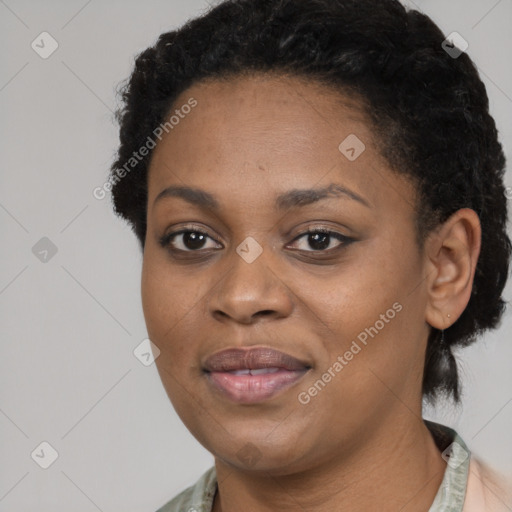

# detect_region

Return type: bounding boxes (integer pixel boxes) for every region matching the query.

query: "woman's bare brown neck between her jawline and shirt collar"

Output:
[213,418,446,512]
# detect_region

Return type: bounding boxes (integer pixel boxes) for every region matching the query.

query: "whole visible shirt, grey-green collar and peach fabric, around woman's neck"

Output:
[156,420,512,512]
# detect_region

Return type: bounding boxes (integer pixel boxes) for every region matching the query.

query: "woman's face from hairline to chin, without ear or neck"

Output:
[142,76,428,474]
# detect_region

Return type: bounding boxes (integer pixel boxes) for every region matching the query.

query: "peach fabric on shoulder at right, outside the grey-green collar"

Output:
[463,457,512,512]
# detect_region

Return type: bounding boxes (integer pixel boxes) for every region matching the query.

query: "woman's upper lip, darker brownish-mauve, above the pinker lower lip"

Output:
[204,347,310,372]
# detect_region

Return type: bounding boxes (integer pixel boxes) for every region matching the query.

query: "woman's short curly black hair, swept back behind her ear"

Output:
[110,0,511,402]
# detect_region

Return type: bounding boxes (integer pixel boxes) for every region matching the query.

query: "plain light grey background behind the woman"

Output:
[0,0,512,512]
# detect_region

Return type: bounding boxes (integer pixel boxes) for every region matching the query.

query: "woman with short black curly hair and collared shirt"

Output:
[111,0,512,512]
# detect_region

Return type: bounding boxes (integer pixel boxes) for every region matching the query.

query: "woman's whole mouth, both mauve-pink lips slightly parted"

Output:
[203,347,311,404]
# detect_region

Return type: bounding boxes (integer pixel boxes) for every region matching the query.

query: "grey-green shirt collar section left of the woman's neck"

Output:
[156,467,217,512]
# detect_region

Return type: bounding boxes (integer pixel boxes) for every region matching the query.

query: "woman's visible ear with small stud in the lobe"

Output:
[425,208,482,329]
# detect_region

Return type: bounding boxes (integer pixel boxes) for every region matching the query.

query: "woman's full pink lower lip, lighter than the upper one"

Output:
[206,369,308,404]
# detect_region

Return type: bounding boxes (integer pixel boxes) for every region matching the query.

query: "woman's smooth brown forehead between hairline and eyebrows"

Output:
[144,75,412,213]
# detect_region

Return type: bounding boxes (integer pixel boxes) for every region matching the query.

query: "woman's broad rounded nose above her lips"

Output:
[208,241,293,324]
